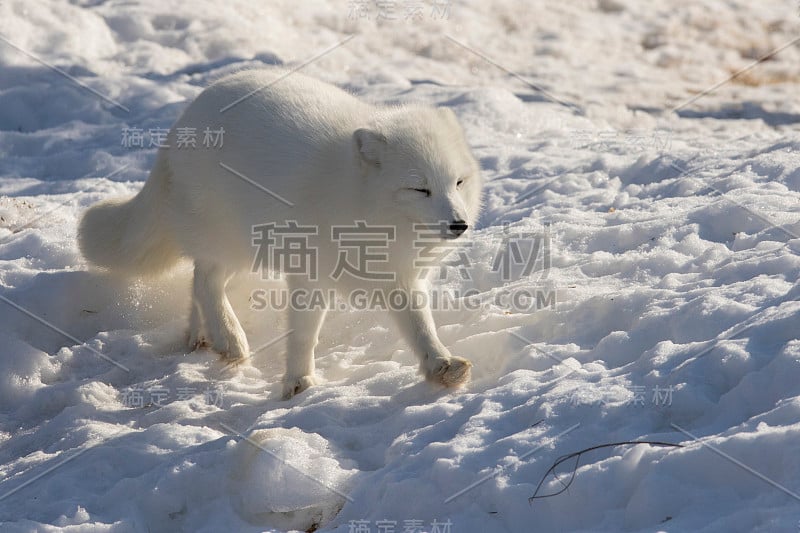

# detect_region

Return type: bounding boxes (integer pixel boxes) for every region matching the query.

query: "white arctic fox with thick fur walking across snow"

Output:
[79,68,483,398]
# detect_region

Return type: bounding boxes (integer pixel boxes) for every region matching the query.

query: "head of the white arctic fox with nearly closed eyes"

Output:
[353,108,483,239]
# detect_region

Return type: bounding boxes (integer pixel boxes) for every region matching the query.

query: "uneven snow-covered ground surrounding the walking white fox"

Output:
[0,0,800,533]
